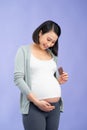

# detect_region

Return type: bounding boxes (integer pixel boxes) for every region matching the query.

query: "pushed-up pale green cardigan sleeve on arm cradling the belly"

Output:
[14,47,31,95]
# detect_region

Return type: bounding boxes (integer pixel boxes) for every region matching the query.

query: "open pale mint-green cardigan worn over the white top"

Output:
[14,45,63,114]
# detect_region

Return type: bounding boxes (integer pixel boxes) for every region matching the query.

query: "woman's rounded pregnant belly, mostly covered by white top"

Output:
[31,78,61,102]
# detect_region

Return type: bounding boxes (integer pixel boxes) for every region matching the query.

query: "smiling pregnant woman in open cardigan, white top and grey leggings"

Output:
[14,20,68,130]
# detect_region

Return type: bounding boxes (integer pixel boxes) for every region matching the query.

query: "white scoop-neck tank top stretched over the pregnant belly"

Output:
[30,54,61,99]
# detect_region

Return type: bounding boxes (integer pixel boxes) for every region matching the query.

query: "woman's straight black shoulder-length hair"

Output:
[32,20,61,56]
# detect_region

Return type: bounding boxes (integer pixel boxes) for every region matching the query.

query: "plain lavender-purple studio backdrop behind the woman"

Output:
[0,0,87,130]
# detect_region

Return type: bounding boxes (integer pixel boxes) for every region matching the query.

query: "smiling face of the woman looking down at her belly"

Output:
[39,31,58,50]
